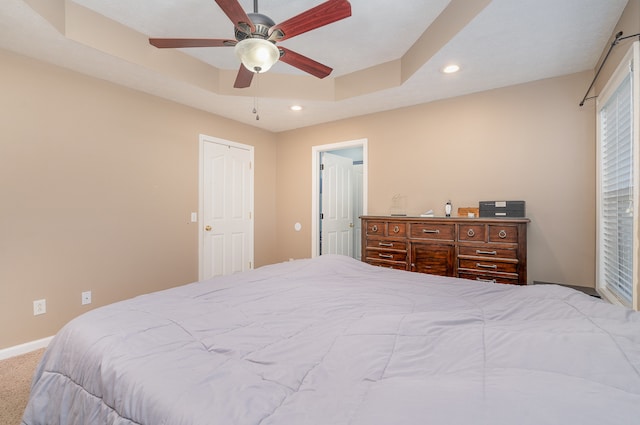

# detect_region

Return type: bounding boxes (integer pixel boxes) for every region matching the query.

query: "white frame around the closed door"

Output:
[197,134,255,281]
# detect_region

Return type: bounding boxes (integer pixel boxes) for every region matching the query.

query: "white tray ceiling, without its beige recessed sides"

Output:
[0,0,627,132]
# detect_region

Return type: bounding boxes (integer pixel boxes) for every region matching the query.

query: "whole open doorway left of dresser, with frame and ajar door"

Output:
[311,139,368,260]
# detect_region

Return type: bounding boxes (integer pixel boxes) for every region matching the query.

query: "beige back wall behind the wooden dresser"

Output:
[277,72,595,286]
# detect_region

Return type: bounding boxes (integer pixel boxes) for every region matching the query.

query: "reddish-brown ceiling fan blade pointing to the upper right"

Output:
[269,0,351,41]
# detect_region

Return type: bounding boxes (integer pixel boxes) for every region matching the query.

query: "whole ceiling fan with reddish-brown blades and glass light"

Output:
[149,0,351,88]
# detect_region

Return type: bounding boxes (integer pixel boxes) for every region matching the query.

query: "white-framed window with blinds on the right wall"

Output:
[597,42,640,310]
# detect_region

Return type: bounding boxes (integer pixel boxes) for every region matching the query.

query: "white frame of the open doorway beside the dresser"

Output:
[311,138,369,258]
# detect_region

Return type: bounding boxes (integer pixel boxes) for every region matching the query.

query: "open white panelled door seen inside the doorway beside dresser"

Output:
[321,152,354,257]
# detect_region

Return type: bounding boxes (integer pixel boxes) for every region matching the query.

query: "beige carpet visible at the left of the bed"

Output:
[0,348,44,425]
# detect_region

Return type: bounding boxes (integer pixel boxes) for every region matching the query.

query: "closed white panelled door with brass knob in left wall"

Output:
[200,138,253,280]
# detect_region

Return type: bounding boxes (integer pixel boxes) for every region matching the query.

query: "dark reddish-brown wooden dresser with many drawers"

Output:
[362,216,530,285]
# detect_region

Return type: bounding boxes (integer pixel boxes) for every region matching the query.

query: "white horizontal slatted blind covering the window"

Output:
[600,69,635,305]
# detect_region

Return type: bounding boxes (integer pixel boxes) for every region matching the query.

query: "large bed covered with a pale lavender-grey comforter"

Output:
[22,255,640,425]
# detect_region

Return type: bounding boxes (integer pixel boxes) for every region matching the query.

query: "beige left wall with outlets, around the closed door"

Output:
[0,51,276,348]
